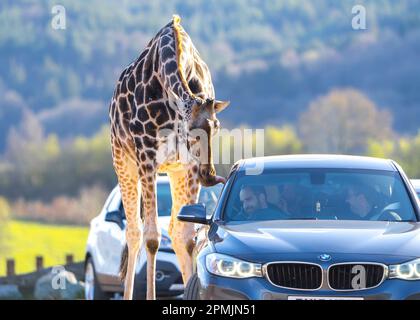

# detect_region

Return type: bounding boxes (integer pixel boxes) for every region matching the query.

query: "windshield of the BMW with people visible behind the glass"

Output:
[224,169,417,221]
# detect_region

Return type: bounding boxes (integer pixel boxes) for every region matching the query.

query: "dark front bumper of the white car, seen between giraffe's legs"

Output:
[135,251,184,298]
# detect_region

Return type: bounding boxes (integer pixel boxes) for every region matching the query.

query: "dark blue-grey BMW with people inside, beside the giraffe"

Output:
[178,155,420,300]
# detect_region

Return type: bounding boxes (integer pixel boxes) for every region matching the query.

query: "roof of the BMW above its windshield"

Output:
[239,154,397,171]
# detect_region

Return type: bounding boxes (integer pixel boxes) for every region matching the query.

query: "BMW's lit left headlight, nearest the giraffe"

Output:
[206,253,262,278]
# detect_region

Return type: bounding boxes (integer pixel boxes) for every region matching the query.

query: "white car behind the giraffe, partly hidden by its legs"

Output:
[85,176,222,300]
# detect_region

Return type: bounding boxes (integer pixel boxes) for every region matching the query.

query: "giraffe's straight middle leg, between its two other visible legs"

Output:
[140,170,162,300]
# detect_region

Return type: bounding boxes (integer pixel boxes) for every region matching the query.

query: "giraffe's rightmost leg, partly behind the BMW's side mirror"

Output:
[169,166,200,285]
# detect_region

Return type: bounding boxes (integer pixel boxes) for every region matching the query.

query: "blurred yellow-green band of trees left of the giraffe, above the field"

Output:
[0,121,116,200]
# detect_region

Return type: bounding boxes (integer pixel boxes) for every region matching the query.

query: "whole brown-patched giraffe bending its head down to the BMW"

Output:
[109,15,229,300]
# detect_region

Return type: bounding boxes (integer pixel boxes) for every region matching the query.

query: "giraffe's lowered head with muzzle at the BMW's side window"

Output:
[187,99,229,186]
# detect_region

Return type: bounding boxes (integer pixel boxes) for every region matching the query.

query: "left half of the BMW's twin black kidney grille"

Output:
[267,263,322,290]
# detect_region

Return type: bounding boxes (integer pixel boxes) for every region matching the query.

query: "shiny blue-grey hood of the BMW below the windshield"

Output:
[212,220,420,262]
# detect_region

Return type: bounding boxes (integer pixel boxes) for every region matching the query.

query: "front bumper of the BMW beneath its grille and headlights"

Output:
[197,270,420,300]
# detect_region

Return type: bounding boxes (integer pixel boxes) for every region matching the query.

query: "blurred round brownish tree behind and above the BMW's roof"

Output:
[299,89,394,154]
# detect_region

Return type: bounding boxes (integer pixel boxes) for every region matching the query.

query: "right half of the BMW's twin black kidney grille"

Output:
[328,263,385,290]
